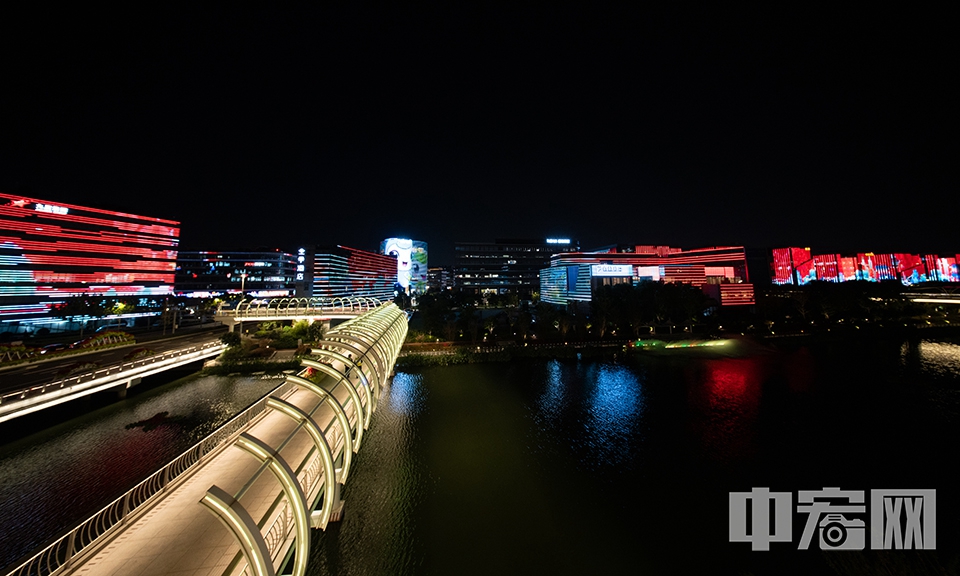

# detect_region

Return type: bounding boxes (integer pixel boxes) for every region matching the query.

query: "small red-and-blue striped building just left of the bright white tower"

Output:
[310,246,399,302]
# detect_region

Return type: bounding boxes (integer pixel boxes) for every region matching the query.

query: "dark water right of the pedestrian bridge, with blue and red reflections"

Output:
[309,340,960,575]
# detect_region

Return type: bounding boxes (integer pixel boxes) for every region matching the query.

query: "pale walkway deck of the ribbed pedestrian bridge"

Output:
[64,380,346,576]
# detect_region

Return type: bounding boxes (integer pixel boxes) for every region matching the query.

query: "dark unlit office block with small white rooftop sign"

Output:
[454,238,580,297]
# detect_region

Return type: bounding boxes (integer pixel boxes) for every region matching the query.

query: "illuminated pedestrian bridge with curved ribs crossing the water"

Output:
[10,303,407,576]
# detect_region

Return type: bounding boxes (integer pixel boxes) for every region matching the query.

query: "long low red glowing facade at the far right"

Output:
[772,248,960,286]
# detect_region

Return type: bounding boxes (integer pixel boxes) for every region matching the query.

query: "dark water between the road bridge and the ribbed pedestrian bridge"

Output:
[0,376,281,569]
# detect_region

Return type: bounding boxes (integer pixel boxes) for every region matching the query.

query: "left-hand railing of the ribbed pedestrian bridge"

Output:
[8,382,296,576]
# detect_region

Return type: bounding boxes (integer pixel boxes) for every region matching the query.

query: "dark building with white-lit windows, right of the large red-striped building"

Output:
[176,250,297,298]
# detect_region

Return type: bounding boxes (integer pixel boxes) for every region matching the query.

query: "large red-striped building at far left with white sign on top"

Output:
[0,192,180,331]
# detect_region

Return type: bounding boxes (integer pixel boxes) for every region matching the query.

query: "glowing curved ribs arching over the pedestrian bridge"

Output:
[201,298,407,576]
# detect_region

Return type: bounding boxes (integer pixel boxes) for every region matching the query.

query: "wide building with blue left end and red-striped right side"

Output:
[540,245,755,306]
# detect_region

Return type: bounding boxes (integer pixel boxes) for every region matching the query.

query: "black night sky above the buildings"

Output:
[0,2,960,264]
